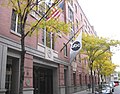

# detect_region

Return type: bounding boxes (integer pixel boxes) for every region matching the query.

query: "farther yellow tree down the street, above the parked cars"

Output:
[93,52,117,84]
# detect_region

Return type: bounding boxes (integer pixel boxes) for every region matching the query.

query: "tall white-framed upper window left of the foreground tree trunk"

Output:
[11,9,21,34]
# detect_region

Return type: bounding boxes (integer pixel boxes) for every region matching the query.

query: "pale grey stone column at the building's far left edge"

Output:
[0,43,7,94]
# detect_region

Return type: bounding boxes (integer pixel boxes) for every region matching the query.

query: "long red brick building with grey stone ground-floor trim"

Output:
[0,0,96,94]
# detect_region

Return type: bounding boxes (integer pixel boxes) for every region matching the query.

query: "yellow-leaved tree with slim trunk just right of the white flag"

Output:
[81,33,120,93]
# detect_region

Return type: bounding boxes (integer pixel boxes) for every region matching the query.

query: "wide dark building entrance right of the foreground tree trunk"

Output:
[33,66,53,94]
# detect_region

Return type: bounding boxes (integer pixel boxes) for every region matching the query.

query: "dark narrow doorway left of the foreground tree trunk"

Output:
[5,56,19,94]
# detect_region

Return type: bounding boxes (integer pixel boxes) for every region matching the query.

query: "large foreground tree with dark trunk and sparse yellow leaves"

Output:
[2,0,68,94]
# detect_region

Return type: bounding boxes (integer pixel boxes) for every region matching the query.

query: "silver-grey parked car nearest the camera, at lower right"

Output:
[95,84,113,94]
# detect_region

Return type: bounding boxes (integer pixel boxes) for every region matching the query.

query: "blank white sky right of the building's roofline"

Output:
[78,0,120,71]
